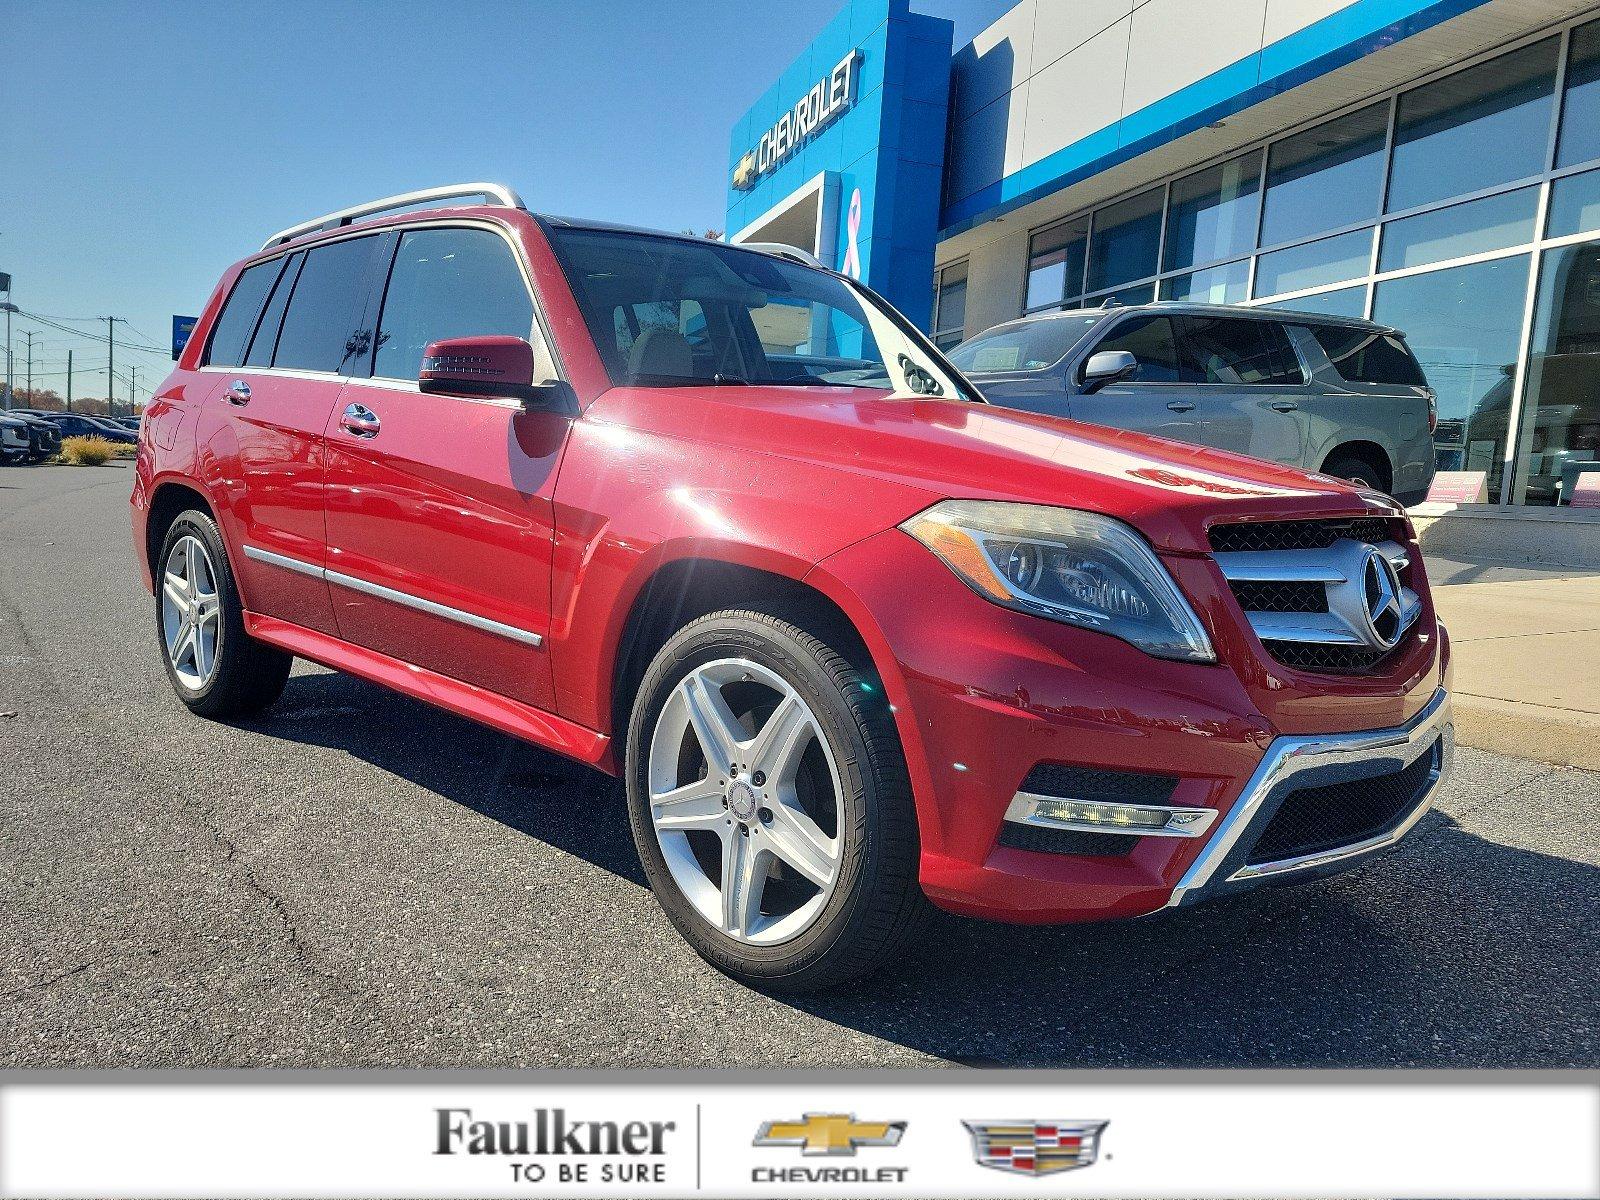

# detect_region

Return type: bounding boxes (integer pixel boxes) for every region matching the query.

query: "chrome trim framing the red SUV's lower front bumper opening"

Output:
[1166,688,1454,907]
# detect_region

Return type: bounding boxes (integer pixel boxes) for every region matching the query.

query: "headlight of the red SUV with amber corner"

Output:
[901,501,1216,662]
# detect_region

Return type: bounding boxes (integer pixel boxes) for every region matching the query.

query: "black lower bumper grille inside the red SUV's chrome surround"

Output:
[1245,741,1438,866]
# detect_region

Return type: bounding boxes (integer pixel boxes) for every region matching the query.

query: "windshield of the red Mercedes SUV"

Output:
[550,227,963,398]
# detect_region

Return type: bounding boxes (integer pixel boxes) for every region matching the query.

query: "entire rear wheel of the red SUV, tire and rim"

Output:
[155,509,294,717]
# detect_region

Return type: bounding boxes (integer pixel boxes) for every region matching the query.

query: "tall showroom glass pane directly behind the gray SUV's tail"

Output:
[1373,254,1528,498]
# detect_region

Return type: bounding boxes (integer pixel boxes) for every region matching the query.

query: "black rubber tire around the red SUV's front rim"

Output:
[624,610,931,992]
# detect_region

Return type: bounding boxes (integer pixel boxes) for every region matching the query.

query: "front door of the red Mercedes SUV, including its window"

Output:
[316,226,568,709]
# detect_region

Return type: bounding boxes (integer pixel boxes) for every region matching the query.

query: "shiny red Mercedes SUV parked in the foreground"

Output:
[133,184,1451,987]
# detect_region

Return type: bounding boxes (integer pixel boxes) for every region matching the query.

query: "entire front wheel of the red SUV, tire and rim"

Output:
[626,611,926,989]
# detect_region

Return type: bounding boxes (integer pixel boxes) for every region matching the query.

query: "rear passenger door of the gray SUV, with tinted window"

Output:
[1178,314,1312,466]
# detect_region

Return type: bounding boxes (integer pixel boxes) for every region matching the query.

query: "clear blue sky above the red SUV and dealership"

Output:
[0,0,1014,400]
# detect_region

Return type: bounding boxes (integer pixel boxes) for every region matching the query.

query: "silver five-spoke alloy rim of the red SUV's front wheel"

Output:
[648,659,843,946]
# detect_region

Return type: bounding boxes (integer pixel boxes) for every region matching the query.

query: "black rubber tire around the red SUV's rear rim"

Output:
[154,509,294,720]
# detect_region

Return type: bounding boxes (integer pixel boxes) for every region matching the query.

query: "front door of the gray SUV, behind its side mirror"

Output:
[1070,314,1250,453]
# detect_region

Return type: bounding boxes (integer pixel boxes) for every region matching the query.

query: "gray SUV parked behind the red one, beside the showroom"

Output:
[950,302,1437,504]
